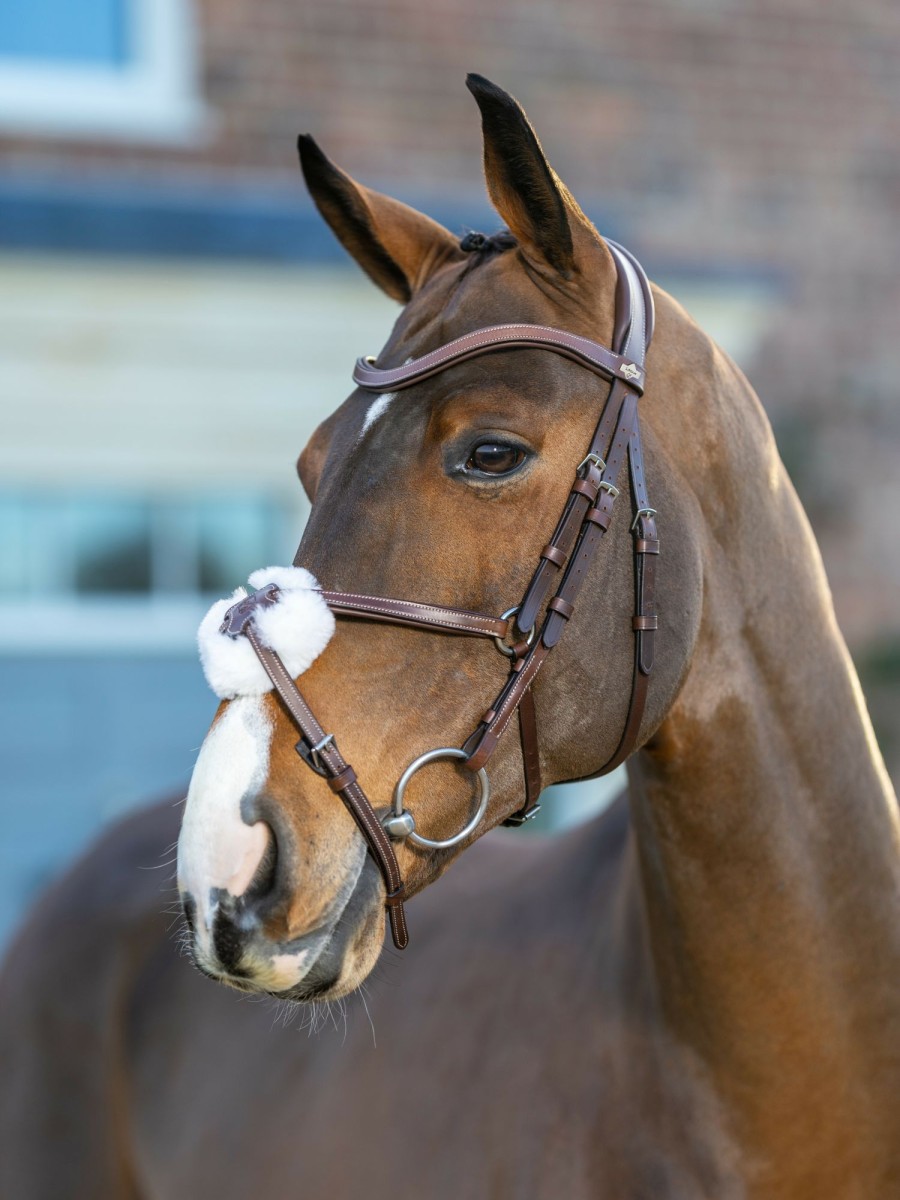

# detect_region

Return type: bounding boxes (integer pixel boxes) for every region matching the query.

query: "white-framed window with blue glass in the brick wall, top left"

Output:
[0,0,206,142]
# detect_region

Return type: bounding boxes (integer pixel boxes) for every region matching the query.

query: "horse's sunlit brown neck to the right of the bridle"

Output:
[631,350,900,1196]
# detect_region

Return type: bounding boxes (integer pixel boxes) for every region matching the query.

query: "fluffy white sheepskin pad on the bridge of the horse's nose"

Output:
[197,566,335,700]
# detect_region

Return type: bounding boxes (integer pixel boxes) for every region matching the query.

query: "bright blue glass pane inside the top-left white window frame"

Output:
[0,0,131,66]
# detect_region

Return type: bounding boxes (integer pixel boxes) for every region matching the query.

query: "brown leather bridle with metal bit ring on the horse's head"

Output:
[222,240,659,949]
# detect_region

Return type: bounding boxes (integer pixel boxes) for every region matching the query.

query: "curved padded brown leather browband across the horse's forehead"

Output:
[353,324,644,395]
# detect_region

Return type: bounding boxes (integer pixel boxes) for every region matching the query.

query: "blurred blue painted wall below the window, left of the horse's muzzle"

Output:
[0,654,217,946]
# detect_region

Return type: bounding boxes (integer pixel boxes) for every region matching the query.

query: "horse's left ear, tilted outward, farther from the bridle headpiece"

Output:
[298,133,464,304]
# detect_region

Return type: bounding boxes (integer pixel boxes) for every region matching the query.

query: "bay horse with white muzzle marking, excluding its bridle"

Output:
[0,76,900,1200]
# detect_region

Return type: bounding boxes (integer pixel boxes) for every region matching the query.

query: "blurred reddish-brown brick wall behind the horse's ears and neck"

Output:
[0,0,900,763]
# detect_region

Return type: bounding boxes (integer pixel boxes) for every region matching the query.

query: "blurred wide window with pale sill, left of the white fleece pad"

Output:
[0,492,292,652]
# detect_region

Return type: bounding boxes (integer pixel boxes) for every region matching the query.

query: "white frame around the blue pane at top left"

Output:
[0,0,211,144]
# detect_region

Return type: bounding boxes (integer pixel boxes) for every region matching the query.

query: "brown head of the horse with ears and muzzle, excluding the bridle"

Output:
[179,77,702,998]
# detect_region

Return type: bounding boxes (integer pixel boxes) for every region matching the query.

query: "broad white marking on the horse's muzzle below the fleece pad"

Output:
[178,696,272,936]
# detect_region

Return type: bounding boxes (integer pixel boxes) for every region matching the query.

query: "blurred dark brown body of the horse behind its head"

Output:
[0,799,743,1200]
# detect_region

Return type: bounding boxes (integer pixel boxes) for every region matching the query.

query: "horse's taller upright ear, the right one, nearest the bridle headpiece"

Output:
[466,74,598,276]
